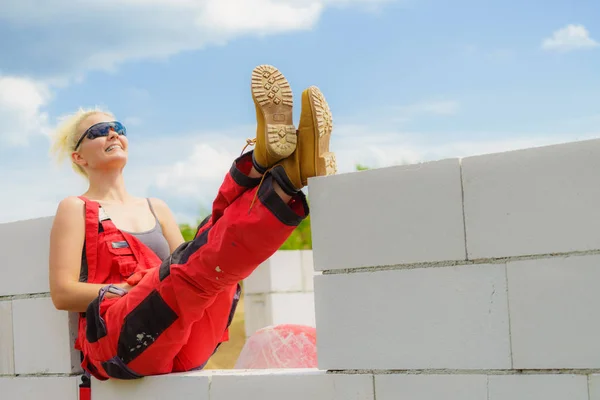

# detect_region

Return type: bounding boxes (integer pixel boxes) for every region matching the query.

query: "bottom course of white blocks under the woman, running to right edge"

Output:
[94,370,600,400]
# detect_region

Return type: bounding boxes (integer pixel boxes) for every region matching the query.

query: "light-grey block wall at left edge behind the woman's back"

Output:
[0,217,81,400]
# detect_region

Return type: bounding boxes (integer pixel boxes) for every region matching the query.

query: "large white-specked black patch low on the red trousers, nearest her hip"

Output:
[117,290,179,364]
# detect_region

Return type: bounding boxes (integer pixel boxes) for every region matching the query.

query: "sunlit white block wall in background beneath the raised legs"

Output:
[244,250,315,337]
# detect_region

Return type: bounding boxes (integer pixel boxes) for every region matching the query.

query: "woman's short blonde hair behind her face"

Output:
[50,107,114,179]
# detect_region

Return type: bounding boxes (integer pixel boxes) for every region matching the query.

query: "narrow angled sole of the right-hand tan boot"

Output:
[308,86,337,176]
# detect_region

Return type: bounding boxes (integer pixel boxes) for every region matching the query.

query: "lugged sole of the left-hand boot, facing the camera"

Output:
[252,65,298,161]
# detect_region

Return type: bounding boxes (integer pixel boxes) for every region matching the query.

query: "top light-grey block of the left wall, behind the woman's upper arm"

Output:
[0,217,54,296]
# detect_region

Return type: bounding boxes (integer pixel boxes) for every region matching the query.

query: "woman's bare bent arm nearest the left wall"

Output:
[49,197,125,312]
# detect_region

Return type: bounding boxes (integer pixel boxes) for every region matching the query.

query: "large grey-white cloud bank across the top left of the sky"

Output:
[0,0,389,79]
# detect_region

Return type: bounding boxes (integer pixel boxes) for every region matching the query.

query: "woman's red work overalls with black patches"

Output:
[75,152,308,380]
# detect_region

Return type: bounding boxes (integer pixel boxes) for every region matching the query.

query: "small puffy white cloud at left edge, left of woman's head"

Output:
[0,76,51,146]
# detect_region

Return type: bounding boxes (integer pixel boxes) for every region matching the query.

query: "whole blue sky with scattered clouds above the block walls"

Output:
[0,0,600,222]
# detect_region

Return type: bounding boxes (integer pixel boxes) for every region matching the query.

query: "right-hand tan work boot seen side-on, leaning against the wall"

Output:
[271,86,337,195]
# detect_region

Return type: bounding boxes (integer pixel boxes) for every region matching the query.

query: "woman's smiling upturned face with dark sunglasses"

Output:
[74,113,129,174]
